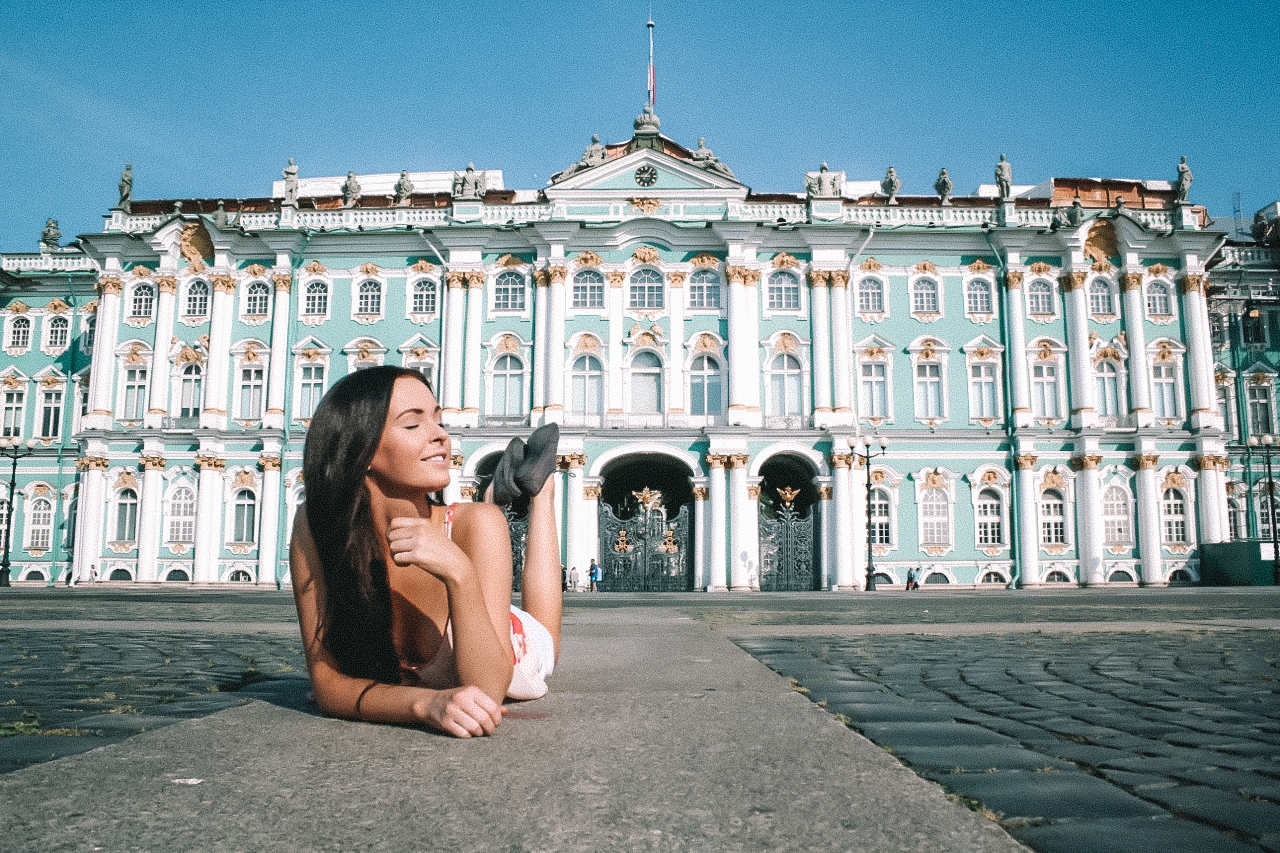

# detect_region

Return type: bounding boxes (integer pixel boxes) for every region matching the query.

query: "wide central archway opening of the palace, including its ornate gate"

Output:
[599,455,694,592]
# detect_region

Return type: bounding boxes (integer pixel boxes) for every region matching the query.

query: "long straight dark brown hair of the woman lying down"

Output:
[302,366,439,684]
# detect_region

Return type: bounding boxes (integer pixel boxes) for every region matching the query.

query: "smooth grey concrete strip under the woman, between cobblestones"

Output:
[0,607,1025,853]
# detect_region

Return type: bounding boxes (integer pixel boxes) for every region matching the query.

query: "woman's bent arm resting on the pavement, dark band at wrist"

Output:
[289,510,511,738]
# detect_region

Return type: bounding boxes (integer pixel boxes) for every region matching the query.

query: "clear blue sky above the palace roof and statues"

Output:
[0,0,1280,251]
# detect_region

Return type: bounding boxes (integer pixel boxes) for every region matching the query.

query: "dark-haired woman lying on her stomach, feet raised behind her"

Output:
[289,366,562,738]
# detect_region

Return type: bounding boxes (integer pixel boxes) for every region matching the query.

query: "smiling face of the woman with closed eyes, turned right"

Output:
[369,377,449,500]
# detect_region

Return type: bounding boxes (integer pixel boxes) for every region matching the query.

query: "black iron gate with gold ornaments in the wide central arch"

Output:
[600,488,694,592]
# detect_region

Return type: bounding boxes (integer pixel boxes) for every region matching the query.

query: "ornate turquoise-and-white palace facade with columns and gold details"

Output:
[0,108,1231,592]
